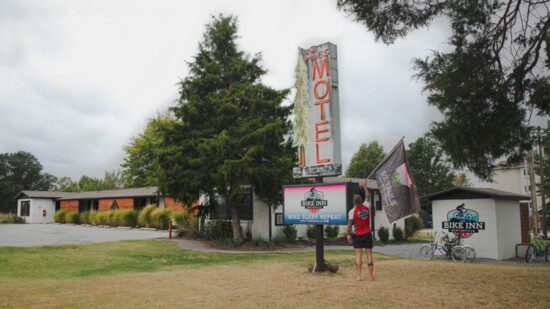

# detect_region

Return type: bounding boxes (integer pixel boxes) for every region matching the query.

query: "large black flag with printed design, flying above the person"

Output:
[375,139,420,223]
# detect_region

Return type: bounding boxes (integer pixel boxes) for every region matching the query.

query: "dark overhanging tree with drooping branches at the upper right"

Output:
[337,0,550,180]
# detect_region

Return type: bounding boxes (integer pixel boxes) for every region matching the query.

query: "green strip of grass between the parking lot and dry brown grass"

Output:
[0,240,392,280]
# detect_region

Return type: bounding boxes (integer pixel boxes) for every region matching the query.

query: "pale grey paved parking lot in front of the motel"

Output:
[0,224,168,247]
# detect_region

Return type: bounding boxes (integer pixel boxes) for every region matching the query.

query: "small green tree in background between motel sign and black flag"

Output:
[346,141,386,178]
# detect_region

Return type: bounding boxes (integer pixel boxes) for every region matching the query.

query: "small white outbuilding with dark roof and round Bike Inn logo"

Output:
[423,187,529,260]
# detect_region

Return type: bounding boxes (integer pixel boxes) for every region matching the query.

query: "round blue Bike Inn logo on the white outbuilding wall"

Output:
[442,203,485,238]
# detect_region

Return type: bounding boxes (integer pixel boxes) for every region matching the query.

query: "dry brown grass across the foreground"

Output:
[0,252,550,308]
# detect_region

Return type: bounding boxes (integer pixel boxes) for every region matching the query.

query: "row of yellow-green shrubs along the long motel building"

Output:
[54,205,197,230]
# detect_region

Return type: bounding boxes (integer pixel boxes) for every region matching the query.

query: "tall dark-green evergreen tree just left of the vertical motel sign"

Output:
[158,15,295,242]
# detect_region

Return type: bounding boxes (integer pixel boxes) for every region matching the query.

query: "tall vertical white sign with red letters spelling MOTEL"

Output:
[293,43,342,178]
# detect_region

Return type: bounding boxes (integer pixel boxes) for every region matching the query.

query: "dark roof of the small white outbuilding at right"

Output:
[422,187,531,201]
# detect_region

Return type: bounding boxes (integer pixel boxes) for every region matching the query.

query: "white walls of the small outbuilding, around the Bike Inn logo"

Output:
[432,199,521,260]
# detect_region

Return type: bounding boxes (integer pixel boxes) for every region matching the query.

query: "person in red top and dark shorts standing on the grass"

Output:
[346,183,374,281]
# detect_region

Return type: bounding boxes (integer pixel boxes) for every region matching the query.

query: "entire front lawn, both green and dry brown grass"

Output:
[0,240,550,309]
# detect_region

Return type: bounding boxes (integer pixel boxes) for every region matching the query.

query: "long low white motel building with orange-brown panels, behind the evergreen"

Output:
[15,177,405,239]
